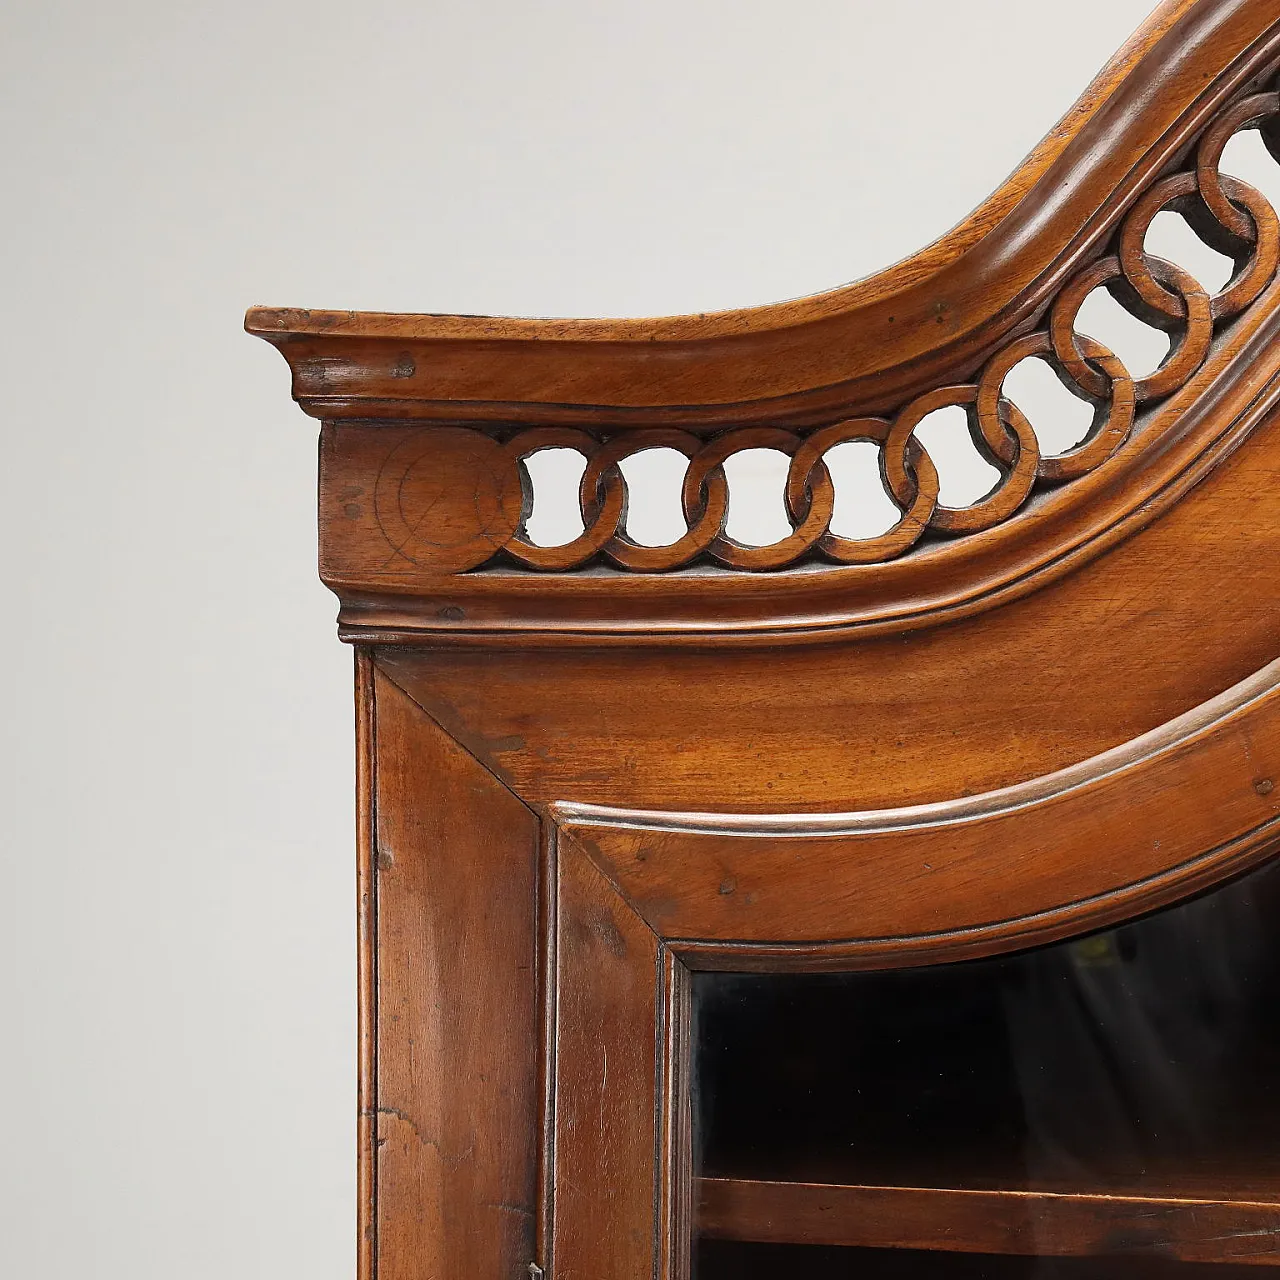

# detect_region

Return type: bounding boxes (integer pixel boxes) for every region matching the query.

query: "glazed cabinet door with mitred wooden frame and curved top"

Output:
[547,664,1280,1280]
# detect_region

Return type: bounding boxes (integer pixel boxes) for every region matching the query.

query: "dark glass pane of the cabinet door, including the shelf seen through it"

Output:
[694,861,1280,1264]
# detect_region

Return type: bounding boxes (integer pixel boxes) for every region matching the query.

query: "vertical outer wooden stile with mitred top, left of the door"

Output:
[375,676,539,1280]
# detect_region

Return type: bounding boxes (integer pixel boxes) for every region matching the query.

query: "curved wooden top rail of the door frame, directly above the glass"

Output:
[548,659,1280,970]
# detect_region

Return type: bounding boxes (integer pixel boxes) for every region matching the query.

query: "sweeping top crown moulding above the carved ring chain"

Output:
[246,0,1280,419]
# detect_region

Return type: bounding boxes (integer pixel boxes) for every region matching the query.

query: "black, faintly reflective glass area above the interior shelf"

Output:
[694,864,1280,1199]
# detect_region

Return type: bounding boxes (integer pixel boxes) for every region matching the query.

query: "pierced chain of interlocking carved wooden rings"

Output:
[478,78,1280,573]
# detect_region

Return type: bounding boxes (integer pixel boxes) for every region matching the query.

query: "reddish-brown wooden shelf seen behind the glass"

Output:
[696,1178,1280,1266]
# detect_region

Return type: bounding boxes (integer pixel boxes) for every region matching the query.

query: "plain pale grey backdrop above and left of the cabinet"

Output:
[0,0,1208,1280]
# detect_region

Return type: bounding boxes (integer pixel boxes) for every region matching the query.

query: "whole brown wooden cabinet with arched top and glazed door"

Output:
[247,0,1280,1280]
